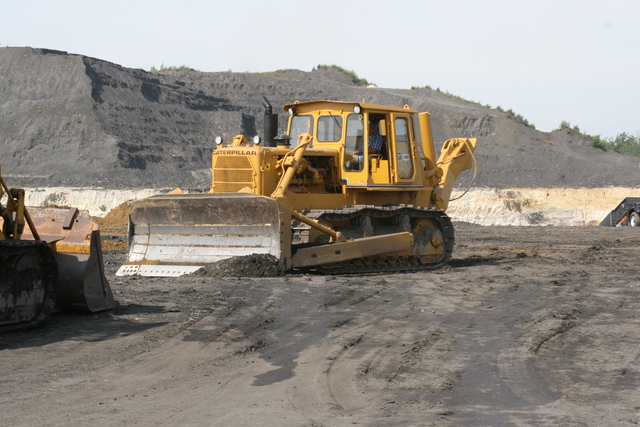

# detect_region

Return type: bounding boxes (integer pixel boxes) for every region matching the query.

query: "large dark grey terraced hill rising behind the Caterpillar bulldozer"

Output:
[0,47,640,189]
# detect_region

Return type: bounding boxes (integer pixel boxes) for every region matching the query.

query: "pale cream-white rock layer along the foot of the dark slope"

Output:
[6,187,640,226]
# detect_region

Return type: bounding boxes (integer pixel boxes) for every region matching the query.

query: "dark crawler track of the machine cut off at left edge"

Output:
[0,240,58,332]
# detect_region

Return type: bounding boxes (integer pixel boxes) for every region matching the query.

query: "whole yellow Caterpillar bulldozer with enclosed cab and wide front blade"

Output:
[116,99,476,276]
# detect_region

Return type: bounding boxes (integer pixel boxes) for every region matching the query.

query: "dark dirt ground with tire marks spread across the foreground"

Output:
[0,224,640,426]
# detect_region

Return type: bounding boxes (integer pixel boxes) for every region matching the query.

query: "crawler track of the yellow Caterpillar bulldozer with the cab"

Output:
[293,205,455,274]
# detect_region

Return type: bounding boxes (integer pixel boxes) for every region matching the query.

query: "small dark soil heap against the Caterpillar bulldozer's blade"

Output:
[192,254,282,277]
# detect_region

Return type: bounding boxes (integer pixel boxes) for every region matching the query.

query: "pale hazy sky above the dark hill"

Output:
[0,0,640,137]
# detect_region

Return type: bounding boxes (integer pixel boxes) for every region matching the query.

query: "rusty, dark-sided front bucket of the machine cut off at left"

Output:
[23,207,116,313]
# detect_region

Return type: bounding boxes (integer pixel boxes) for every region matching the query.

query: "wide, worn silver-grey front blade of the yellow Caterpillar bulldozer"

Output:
[116,193,290,277]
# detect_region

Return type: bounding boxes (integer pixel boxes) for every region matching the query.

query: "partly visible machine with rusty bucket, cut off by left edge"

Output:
[0,166,115,328]
